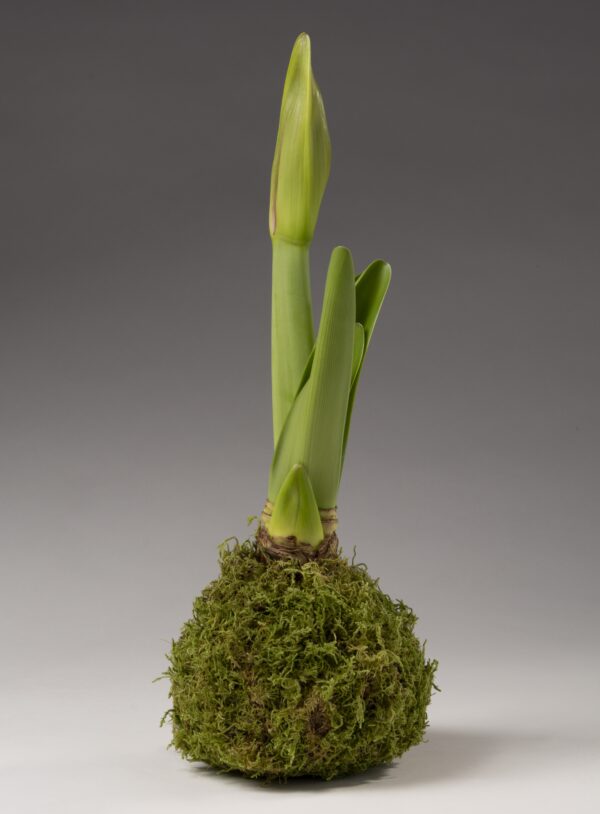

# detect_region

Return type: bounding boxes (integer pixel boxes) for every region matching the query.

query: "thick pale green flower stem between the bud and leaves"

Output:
[271,238,314,445]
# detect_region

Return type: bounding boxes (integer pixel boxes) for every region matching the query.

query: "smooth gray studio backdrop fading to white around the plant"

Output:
[0,1,600,812]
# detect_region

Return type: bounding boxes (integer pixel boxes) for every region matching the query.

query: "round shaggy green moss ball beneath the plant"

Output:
[167,541,437,779]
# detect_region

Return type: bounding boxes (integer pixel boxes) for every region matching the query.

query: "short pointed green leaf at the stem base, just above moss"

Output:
[267,464,323,547]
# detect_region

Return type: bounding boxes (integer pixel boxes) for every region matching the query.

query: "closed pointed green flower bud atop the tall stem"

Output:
[269,34,331,245]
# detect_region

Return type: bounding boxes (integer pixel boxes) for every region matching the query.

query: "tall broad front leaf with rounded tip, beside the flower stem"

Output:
[269,246,356,508]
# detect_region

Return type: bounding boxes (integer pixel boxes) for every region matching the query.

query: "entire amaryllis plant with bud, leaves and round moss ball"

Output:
[163,34,437,779]
